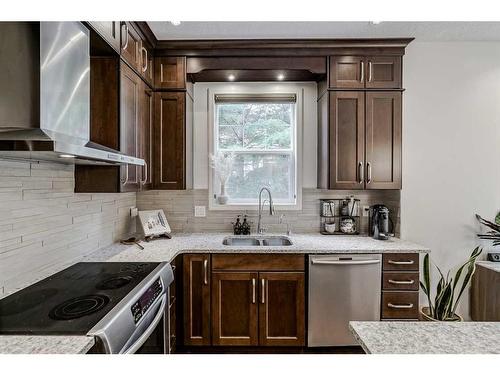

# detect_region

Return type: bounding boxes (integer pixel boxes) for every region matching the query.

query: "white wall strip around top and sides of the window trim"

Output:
[192,82,317,189]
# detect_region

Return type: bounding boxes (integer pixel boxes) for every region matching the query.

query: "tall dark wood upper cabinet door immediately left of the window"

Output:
[153,92,186,190]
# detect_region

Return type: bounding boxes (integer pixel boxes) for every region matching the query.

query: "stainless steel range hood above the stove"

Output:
[0,22,144,165]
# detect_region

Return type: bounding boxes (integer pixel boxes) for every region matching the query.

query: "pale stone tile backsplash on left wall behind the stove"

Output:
[0,159,136,297]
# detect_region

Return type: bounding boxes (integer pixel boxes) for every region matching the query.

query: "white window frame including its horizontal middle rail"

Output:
[207,83,304,211]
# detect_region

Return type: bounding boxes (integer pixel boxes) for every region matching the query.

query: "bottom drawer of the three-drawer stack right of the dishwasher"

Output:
[382,291,418,319]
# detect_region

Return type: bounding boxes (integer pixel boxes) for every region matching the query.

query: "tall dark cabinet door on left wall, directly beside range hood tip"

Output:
[120,62,142,191]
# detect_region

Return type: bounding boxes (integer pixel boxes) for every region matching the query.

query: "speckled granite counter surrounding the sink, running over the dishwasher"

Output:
[84,233,429,262]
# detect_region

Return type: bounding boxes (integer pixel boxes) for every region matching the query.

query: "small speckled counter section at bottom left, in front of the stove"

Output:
[0,336,95,354]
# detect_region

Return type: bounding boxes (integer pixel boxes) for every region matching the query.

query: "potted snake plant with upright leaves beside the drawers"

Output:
[420,247,482,322]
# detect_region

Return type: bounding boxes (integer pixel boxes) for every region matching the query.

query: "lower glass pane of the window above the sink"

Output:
[226,153,295,204]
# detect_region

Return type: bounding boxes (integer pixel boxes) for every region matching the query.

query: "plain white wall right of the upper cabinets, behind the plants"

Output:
[401,42,500,316]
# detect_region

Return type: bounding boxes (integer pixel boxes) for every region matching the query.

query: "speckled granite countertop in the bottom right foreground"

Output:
[349,322,500,354]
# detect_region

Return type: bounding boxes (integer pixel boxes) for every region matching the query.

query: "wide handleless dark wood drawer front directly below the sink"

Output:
[212,254,305,271]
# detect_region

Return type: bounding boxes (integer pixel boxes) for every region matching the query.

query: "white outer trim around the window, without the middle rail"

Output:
[207,83,304,211]
